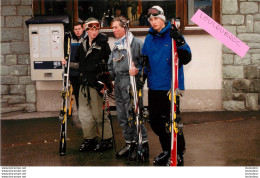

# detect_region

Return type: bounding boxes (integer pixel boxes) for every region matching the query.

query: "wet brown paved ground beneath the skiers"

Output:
[1,112,260,166]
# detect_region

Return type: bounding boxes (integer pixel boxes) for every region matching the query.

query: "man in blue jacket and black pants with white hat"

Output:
[142,6,191,166]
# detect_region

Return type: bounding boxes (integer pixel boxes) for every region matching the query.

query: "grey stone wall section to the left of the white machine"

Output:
[1,0,36,113]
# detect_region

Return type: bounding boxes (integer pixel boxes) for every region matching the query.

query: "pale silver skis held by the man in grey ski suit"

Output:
[125,21,144,161]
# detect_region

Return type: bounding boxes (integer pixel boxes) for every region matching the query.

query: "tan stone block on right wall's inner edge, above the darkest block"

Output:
[222,66,244,79]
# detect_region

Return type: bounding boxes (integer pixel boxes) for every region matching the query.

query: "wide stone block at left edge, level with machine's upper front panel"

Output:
[1,28,23,41]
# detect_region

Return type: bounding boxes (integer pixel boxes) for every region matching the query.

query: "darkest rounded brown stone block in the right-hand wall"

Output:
[232,79,254,93]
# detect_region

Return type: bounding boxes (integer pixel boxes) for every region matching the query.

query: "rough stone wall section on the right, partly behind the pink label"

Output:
[222,0,260,111]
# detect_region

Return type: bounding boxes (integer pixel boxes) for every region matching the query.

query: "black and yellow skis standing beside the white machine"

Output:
[59,32,72,156]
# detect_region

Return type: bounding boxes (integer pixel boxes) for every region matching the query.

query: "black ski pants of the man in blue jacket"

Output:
[148,90,171,151]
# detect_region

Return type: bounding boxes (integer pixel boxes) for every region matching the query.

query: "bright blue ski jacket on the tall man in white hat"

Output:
[142,22,191,90]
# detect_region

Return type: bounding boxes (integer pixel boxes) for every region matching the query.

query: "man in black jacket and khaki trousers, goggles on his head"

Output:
[75,18,113,152]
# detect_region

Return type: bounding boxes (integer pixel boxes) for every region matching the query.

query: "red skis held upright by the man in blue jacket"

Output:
[170,19,180,166]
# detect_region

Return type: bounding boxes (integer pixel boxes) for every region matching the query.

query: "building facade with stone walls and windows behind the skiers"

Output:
[1,0,260,113]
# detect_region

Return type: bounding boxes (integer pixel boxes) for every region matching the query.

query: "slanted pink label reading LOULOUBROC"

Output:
[191,9,249,57]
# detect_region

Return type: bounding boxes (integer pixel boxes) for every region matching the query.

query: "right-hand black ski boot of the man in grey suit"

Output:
[129,141,149,161]
